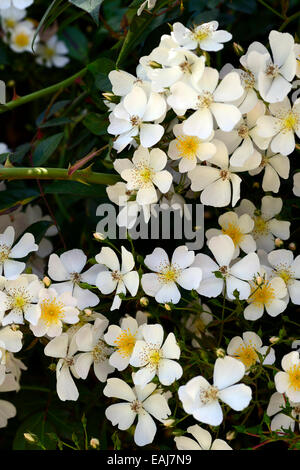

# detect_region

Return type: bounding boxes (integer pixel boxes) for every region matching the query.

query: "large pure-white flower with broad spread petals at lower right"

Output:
[178,356,252,426]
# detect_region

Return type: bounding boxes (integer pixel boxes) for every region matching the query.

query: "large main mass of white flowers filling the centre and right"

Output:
[0,18,300,450]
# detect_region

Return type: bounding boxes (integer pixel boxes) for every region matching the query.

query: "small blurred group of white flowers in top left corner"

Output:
[0,0,69,67]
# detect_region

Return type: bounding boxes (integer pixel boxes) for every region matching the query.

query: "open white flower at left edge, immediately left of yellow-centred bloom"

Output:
[0,274,44,325]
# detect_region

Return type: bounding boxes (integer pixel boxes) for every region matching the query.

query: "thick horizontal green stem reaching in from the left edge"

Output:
[0,168,120,185]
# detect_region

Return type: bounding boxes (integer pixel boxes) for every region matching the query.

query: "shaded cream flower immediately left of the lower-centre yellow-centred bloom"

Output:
[75,319,115,382]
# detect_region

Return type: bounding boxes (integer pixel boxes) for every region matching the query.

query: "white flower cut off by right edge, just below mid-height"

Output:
[268,249,300,305]
